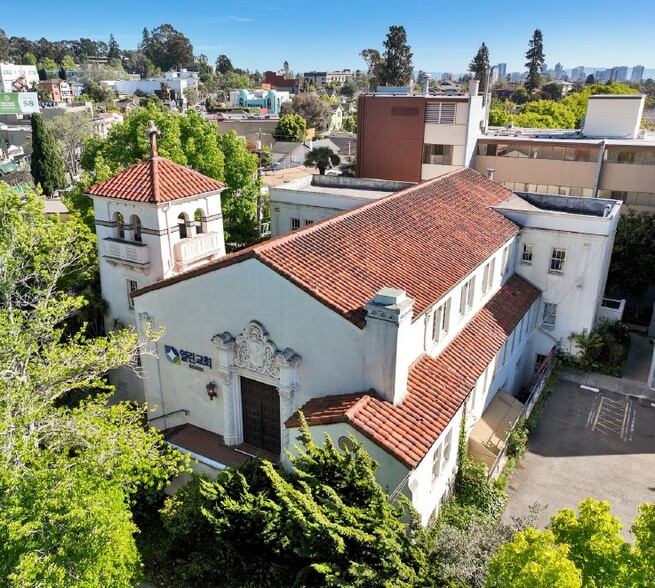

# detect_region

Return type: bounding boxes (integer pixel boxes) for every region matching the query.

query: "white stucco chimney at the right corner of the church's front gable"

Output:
[364,288,415,404]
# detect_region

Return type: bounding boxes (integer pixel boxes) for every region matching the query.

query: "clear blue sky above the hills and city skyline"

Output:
[0,0,655,73]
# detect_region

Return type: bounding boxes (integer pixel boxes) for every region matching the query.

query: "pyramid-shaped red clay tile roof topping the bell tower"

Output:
[88,157,225,203]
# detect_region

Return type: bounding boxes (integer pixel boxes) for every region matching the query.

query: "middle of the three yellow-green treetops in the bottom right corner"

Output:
[550,498,630,588]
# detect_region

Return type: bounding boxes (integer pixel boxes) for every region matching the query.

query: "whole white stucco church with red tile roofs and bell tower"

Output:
[89,134,620,521]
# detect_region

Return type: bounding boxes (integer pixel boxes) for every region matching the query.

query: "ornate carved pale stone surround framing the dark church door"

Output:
[212,321,302,450]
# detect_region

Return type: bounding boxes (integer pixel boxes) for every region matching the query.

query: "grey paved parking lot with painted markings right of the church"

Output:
[504,380,655,537]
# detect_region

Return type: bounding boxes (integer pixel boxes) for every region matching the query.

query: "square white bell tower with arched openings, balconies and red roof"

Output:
[88,121,225,401]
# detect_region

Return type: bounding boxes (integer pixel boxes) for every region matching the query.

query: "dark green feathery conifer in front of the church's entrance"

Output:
[152,426,434,588]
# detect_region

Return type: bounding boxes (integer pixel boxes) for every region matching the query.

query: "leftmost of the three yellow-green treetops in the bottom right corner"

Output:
[487,527,582,588]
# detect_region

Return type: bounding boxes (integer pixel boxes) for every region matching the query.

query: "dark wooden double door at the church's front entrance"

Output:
[241,377,280,455]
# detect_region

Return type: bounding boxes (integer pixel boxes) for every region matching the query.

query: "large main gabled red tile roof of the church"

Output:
[135,168,519,328]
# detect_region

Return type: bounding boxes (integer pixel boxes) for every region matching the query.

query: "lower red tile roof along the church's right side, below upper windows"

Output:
[286,275,539,468]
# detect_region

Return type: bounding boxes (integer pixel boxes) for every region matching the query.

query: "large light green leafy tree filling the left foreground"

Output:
[0,183,186,588]
